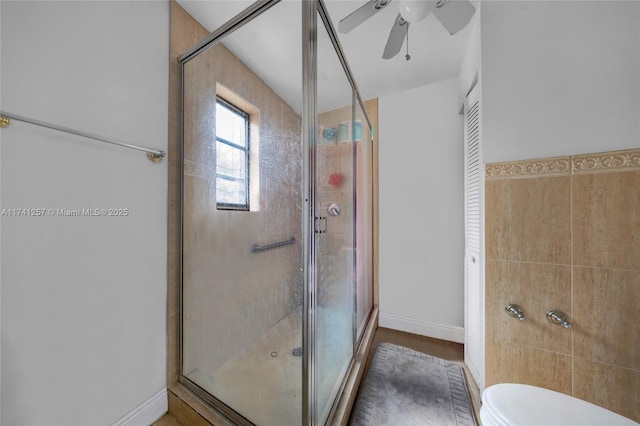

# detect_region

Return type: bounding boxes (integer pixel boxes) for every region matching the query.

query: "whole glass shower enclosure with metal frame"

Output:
[180,0,373,426]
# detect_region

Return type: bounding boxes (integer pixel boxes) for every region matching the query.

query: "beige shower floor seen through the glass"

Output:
[185,308,352,426]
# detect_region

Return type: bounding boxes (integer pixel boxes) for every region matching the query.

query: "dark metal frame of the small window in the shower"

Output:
[215,95,251,211]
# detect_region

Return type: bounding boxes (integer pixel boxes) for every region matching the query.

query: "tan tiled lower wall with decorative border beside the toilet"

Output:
[485,149,640,421]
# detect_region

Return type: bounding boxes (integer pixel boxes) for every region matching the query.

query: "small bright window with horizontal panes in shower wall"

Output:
[216,96,249,210]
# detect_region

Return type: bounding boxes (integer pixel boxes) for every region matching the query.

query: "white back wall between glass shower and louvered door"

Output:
[379,78,464,341]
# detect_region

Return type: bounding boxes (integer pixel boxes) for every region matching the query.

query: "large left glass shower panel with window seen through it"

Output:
[181,2,304,426]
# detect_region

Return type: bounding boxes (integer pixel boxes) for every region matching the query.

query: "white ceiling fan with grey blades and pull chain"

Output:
[338,0,476,61]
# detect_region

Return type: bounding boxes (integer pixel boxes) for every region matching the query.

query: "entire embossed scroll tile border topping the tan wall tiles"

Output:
[485,149,640,179]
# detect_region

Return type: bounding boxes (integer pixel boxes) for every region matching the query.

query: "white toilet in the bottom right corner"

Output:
[480,383,640,426]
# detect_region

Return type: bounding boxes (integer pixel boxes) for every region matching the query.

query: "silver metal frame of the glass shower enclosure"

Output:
[178,0,373,426]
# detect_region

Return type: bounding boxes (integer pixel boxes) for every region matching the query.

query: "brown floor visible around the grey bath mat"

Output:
[152,328,480,426]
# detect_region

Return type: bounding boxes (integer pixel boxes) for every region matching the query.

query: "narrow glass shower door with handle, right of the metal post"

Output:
[315,10,355,425]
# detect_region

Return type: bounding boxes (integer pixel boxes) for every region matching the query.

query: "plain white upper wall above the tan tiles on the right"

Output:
[482,1,640,162]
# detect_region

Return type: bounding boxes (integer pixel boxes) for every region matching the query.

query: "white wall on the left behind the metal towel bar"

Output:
[0,1,169,426]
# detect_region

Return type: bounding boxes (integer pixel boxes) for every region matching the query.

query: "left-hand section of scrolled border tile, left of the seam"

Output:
[485,157,571,179]
